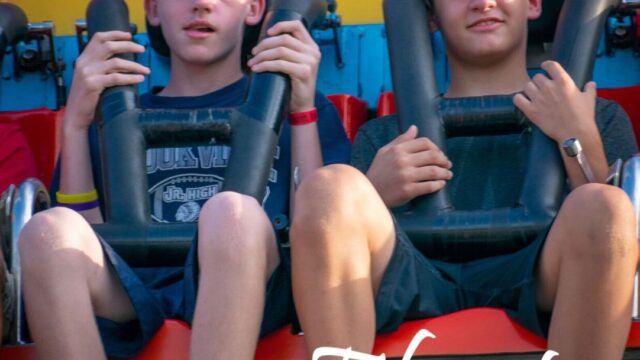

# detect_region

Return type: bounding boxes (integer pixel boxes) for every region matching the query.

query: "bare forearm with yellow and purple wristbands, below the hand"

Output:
[59,119,103,224]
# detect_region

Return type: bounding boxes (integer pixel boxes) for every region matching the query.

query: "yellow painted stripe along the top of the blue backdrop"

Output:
[6,0,382,35]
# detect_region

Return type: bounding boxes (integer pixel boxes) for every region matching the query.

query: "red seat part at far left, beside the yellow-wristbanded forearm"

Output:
[0,108,63,187]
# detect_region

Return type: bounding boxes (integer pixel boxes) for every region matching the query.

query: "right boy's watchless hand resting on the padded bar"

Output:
[367,126,453,208]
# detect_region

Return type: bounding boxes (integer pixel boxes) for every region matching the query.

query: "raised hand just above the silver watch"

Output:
[513,61,598,144]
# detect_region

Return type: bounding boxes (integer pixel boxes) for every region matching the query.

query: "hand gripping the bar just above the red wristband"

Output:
[248,21,320,112]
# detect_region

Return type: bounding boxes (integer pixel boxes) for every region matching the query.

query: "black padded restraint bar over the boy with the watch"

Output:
[384,0,618,261]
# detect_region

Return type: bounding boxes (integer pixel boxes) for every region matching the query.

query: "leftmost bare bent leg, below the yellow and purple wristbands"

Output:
[20,208,135,359]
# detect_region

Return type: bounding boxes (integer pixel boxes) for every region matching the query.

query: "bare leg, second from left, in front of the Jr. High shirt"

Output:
[191,192,280,359]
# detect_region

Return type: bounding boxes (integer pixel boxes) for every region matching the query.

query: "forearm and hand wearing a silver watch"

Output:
[514,61,609,189]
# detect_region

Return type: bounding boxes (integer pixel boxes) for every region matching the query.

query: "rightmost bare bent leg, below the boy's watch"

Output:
[538,184,638,360]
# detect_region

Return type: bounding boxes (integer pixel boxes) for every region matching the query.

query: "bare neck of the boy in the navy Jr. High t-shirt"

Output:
[159,58,244,97]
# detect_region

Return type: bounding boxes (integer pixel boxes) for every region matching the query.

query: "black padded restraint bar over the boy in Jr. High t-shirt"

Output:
[87,0,325,266]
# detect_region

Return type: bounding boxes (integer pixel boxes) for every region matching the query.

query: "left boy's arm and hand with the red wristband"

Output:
[249,21,323,212]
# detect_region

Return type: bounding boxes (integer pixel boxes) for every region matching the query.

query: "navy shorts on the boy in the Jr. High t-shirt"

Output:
[96,234,295,358]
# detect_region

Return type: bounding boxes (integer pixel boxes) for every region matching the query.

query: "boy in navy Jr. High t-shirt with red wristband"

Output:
[20,0,349,359]
